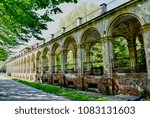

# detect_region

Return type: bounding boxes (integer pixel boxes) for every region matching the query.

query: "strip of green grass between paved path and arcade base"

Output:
[12,78,109,101]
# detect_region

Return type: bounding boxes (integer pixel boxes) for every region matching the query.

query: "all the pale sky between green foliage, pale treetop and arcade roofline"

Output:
[13,0,130,52]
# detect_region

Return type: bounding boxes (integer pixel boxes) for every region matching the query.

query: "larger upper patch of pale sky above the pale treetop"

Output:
[44,0,129,38]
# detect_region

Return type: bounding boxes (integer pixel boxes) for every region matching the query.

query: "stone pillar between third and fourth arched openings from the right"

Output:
[61,50,67,74]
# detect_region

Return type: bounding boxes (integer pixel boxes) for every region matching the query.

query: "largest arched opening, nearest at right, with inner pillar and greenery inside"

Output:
[110,14,146,72]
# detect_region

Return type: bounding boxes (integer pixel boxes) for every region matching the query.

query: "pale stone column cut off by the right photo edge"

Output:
[142,25,150,79]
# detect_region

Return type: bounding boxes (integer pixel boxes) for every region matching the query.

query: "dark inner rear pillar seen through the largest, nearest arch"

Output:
[128,42,137,71]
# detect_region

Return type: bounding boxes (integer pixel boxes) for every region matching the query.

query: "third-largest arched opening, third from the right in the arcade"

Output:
[64,37,77,73]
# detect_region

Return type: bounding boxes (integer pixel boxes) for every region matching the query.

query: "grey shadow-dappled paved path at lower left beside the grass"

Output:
[0,75,70,101]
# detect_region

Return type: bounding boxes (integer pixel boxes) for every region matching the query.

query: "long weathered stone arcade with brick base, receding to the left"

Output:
[6,0,150,95]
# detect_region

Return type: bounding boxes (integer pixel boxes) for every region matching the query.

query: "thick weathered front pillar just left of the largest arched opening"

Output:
[102,37,113,78]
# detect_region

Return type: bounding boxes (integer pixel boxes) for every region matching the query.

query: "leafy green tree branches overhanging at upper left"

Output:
[0,0,77,60]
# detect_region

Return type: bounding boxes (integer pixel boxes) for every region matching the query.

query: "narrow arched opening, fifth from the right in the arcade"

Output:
[43,47,50,73]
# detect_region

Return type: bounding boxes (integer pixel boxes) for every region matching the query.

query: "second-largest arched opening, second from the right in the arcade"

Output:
[81,27,103,75]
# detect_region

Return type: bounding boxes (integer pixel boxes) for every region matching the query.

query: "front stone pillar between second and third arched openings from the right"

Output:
[77,45,84,77]
